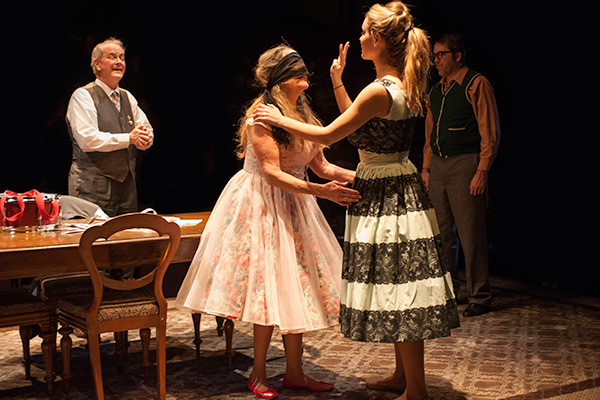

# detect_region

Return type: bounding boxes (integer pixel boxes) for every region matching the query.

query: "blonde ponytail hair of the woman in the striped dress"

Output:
[365,1,431,115]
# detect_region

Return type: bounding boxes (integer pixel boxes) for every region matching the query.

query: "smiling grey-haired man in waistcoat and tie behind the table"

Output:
[66,38,154,216]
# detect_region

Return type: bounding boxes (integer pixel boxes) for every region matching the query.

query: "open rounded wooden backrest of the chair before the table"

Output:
[79,213,181,318]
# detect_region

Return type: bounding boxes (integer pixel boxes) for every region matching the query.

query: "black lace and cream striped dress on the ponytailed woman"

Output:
[340,78,459,343]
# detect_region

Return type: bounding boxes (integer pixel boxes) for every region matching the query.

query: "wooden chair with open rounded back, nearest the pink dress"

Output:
[57,213,181,400]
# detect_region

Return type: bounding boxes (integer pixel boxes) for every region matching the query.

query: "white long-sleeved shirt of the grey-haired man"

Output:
[67,79,154,152]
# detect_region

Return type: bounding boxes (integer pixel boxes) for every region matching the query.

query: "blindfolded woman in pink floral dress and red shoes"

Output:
[176,45,360,398]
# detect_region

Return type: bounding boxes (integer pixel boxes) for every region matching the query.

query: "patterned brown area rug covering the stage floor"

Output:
[0,279,600,400]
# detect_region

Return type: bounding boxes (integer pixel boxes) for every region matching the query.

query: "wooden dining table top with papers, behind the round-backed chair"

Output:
[0,211,210,280]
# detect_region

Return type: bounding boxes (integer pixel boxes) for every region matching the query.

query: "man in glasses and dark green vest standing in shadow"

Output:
[421,34,500,317]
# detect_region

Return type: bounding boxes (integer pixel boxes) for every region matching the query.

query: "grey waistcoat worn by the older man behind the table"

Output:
[67,85,137,182]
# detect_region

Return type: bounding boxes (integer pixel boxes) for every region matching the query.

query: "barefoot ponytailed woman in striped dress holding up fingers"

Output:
[254,1,459,400]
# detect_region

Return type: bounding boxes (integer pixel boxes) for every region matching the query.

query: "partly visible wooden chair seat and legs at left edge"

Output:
[0,288,56,394]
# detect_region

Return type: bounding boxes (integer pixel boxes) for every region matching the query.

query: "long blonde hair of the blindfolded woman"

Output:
[236,44,322,158]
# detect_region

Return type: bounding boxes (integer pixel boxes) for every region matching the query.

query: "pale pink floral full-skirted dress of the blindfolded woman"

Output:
[175,122,342,334]
